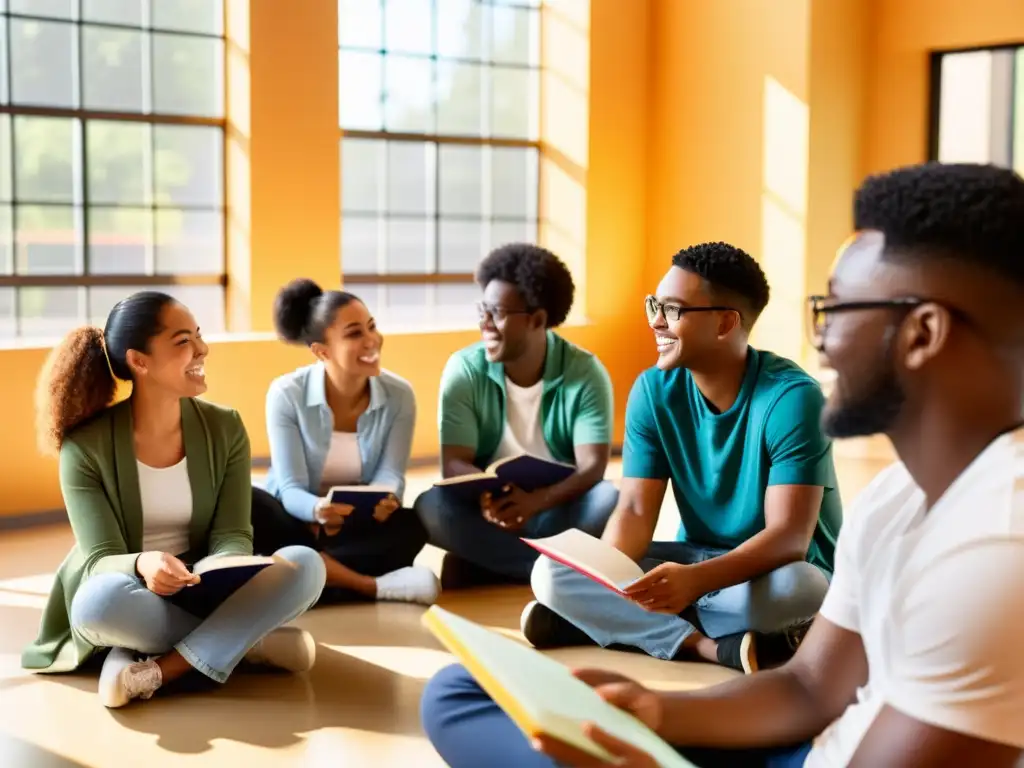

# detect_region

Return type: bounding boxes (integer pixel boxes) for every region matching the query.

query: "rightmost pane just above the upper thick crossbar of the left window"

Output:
[153,33,224,118]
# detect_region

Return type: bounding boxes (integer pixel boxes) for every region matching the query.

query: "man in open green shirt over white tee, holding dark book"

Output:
[416,244,618,588]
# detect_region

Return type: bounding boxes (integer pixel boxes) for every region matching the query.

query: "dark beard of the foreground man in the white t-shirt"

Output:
[821,334,906,438]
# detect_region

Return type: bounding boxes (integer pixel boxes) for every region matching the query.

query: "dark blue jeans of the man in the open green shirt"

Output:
[415,480,618,582]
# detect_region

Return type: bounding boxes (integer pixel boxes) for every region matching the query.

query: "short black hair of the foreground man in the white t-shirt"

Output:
[853,163,1024,287]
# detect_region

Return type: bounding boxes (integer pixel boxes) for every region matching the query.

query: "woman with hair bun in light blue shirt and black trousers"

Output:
[253,279,440,605]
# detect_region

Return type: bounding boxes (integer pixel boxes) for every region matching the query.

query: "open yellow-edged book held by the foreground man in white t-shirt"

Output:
[422,605,693,768]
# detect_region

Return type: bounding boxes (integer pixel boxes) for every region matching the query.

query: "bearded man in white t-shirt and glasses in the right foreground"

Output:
[423,164,1024,768]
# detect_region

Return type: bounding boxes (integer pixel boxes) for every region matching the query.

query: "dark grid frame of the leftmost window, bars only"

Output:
[0,5,230,339]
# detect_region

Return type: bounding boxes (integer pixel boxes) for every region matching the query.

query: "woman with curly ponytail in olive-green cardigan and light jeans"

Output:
[22,292,325,707]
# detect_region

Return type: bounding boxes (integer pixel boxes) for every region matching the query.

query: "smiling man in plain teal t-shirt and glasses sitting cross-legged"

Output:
[522,243,842,672]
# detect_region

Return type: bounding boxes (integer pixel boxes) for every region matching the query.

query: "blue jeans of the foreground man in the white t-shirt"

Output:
[420,665,811,768]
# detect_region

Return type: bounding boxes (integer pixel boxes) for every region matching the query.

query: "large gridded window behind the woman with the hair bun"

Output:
[339,0,541,323]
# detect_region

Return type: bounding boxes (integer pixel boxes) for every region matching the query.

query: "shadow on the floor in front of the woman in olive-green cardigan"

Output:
[104,645,436,755]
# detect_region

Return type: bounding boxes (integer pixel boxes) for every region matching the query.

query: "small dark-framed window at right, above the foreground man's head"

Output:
[931,46,1024,173]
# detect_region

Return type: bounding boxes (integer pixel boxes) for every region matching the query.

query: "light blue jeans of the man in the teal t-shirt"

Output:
[530,542,828,659]
